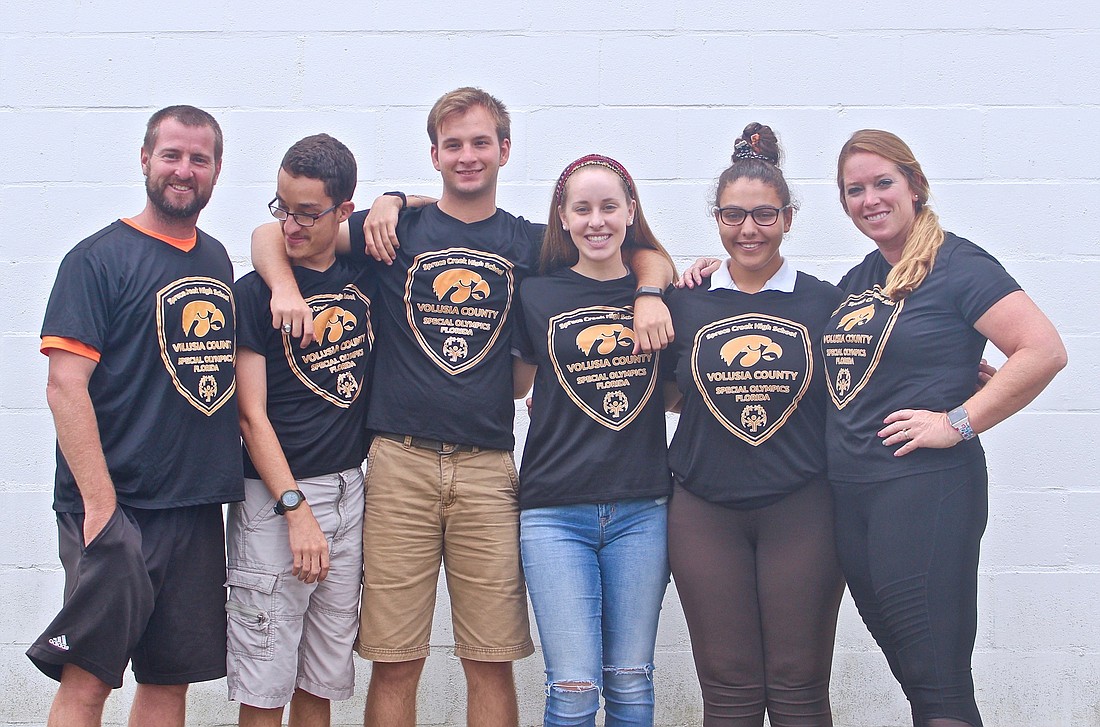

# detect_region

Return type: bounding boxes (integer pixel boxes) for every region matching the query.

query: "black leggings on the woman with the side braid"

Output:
[833,458,988,727]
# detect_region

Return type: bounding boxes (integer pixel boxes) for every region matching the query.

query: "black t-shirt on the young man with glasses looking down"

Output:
[233,260,376,480]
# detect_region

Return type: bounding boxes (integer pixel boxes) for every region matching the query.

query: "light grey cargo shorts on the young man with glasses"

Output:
[226,467,363,709]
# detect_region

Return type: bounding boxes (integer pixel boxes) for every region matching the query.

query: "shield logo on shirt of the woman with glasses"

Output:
[691,313,814,447]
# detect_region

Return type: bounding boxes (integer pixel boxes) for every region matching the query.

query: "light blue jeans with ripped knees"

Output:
[519,497,669,727]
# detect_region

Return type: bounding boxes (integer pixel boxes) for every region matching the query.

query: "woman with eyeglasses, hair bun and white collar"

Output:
[664,123,844,727]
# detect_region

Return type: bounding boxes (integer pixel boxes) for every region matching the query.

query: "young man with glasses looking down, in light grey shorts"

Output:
[226,134,374,727]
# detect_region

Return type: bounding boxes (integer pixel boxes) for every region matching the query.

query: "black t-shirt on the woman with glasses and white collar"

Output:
[666,273,840,509]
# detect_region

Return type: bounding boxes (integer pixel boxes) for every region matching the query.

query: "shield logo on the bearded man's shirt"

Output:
[156,276,237,417]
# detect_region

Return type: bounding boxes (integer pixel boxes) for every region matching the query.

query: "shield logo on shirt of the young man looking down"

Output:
[283,285,374,409]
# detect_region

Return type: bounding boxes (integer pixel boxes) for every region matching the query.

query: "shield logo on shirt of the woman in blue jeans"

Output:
[547,306,658,431]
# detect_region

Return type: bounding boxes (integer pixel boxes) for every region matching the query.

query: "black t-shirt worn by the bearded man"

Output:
[42,220,244,513]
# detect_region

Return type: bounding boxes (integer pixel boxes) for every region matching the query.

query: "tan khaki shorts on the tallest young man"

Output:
[355,437,535,662]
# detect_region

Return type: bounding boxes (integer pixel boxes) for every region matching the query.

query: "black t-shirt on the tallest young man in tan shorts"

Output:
[349,205,545,450]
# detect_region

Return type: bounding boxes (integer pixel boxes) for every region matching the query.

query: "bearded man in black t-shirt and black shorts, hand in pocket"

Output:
[28,106,244,727]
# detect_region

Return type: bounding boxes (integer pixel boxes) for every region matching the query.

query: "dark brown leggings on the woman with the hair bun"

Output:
[669,482,844,727]
